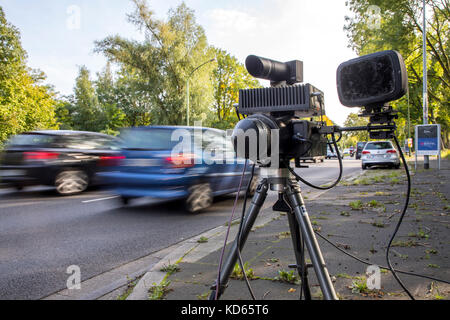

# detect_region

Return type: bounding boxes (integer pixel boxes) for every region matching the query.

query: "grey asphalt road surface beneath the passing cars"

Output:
[0,160,361,299]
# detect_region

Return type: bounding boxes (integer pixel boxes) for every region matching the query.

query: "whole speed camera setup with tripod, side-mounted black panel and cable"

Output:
[210,51,410,300]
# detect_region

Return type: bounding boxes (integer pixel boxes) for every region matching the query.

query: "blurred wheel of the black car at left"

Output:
[55,170,89,196]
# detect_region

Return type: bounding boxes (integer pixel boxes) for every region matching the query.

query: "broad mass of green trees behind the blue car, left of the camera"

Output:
[57,0,260,134]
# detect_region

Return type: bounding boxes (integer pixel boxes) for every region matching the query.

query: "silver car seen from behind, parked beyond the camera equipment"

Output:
[361,141,400,170]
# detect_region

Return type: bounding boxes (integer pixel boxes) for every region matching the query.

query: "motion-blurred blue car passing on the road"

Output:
[100,126,258,212]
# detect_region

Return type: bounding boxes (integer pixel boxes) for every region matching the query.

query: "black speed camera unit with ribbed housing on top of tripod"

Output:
[232,55,327,167]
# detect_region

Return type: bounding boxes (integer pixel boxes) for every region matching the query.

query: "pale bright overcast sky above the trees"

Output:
[0,0,356,125]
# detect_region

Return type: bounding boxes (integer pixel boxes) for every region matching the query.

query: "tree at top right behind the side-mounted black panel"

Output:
[345,0,450,147]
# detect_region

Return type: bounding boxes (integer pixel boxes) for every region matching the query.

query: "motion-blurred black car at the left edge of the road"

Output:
[0,130,121,195]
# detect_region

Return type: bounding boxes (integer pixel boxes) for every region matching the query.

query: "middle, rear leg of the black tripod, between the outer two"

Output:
[287,201,311,300]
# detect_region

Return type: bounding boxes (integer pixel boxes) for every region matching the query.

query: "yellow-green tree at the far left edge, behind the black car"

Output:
[0,7,57,142]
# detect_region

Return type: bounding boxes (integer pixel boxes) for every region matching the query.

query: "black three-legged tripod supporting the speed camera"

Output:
[210,165,338,300]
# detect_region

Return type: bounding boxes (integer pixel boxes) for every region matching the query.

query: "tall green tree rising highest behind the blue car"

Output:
[95,0,213,125]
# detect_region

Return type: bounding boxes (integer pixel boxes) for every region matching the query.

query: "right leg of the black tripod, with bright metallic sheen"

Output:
[285,182,338,300]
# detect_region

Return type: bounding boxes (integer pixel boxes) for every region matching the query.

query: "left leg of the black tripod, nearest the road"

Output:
[209,179,269,300]
